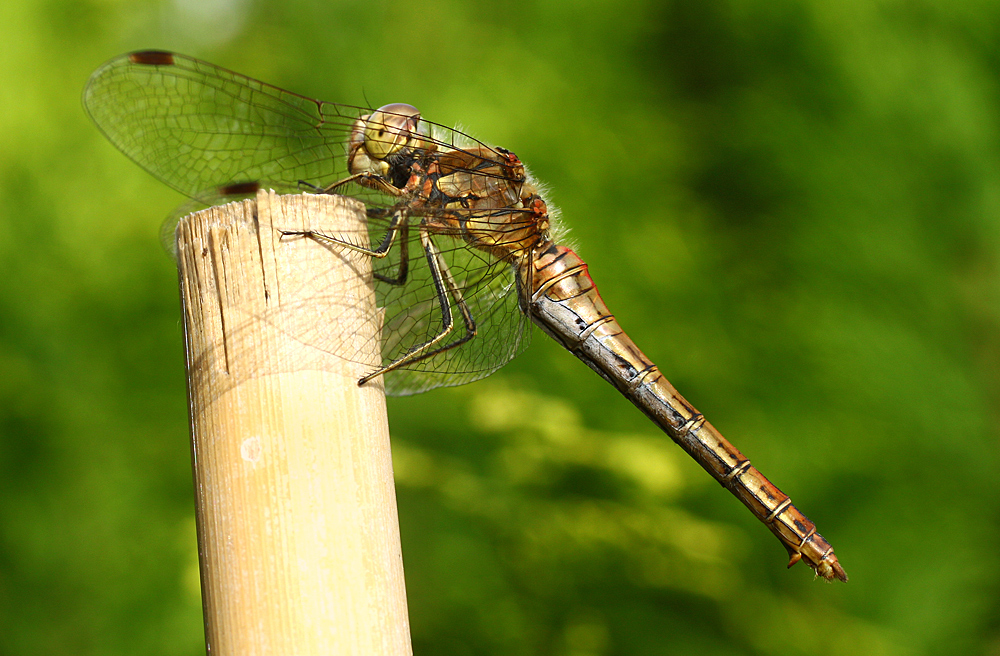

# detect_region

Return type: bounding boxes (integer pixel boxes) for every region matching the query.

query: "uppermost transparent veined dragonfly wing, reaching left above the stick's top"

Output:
[83,53,360,201]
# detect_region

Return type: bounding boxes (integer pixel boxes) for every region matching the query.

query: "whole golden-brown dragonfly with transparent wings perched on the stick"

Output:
[83,50,847,581]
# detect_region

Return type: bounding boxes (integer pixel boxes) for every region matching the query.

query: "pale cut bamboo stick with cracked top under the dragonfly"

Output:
[177,192,412,656]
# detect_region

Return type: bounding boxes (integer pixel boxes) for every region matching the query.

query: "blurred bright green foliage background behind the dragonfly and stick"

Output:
[0,0,1000,656]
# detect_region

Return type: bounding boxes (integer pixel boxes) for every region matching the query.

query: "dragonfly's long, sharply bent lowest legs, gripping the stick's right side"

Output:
[358,228,476,385]
